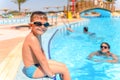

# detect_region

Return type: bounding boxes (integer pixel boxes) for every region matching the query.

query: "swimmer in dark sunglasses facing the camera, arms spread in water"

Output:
[88,42,118,63]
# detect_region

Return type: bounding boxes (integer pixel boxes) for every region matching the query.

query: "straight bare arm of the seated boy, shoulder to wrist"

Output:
[30,38,54,77]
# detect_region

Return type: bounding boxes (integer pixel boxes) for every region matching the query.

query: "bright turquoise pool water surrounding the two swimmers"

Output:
[51,8,120,80]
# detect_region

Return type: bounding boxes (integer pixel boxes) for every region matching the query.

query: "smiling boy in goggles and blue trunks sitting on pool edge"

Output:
[22,11,71,80]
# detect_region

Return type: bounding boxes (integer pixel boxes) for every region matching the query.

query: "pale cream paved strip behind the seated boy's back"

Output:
[0,42,23,80]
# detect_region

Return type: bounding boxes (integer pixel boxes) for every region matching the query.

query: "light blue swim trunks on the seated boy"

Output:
[25,64,40,78]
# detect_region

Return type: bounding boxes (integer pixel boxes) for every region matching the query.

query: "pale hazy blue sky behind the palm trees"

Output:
[0,0,120,13]
